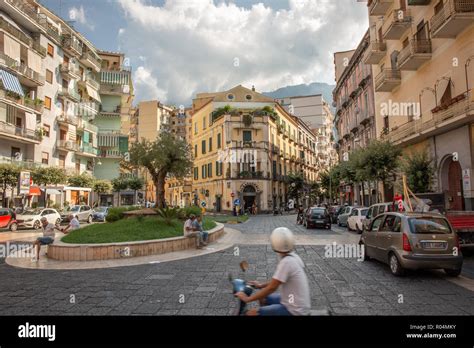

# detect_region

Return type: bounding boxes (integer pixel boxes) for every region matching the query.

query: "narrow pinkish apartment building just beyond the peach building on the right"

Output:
[333,31,376,205]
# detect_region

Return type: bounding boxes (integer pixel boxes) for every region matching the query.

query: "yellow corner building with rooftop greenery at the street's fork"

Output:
[191,85,316,212]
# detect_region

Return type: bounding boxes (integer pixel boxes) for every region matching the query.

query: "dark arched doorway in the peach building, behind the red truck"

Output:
[441,156,464,210]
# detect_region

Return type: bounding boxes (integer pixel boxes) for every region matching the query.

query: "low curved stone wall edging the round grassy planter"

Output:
[48,223,224,261]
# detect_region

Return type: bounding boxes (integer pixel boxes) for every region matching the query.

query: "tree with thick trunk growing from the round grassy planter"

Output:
[122,132,193,208]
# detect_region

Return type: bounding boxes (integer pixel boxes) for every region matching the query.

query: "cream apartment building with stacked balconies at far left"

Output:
[0,0,131,207]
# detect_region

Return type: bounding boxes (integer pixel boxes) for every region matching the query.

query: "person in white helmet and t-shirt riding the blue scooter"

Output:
[235,227,311,316]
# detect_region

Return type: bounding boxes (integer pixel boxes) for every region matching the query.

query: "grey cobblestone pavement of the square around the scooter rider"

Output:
[0,216,474,315]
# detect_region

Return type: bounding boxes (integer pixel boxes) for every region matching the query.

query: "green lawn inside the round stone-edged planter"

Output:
[62,217,216,244]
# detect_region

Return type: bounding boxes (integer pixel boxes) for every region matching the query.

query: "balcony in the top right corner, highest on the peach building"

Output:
[430,0,474,38]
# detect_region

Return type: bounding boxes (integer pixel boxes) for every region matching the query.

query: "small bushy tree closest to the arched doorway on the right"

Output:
[402,151,436,193]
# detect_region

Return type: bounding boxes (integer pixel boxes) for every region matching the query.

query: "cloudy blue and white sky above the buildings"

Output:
[41,0,368,106]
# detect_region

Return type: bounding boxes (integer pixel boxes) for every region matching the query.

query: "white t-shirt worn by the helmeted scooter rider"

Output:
[273,253,311,315]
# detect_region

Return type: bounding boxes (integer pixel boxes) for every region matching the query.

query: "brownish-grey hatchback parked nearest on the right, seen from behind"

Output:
[360,212,463,276]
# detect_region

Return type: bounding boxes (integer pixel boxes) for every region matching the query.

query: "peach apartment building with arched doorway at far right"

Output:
[364,0,474,210]
